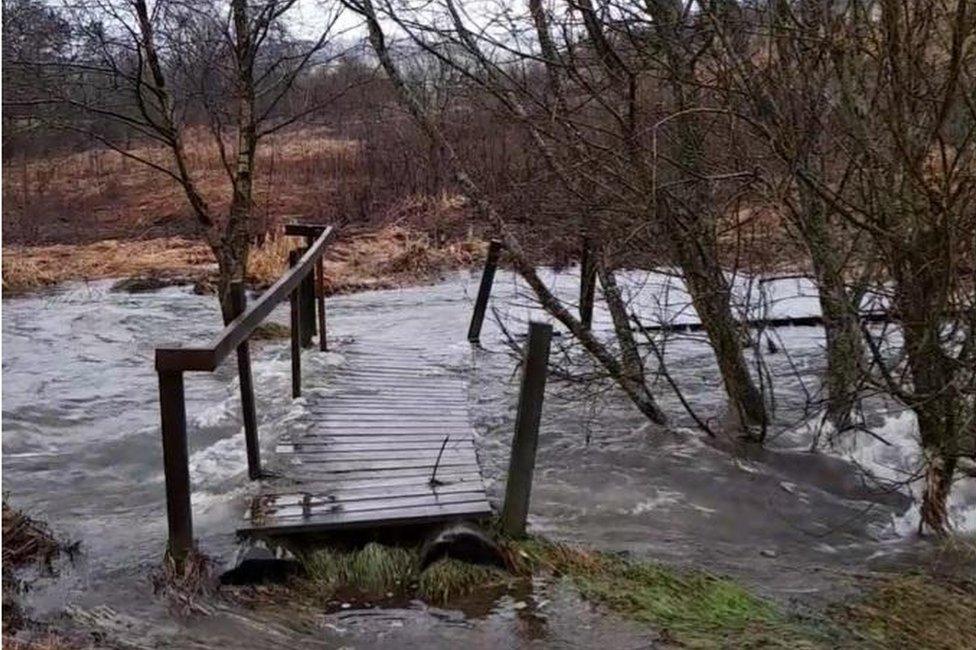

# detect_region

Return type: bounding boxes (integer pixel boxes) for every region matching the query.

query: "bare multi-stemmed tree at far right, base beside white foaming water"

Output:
[712,0,976,534]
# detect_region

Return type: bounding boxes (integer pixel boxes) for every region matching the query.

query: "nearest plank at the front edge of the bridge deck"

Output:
[238,501,491,534]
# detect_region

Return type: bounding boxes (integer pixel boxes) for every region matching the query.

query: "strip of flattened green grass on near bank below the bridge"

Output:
[290,539,976,650]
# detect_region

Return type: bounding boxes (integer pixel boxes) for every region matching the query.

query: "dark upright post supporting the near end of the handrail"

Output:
[159,370,193,566]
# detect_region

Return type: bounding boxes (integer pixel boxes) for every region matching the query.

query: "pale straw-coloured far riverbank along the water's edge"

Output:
[3,225,486,295]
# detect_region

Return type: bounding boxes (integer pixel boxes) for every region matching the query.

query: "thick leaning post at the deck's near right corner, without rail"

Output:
[502,322,552,537]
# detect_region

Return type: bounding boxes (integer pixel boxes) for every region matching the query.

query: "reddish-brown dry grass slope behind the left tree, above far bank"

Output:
[3,128,359,243]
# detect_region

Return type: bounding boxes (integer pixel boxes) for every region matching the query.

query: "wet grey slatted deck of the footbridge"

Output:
[240,344,491,534]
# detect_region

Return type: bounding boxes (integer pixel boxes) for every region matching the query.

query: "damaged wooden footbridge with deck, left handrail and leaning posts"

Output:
[156,225,551,558]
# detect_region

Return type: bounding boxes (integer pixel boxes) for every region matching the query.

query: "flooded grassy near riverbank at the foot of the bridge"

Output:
[9,503,976,650]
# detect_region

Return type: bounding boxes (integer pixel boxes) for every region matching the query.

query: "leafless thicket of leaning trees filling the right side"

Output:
[346,0,976,533]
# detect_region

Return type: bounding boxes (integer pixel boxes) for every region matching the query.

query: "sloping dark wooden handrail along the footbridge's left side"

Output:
[156,226,335,372]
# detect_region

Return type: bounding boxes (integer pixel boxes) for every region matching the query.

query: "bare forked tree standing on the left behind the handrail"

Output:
[5,0,346,317]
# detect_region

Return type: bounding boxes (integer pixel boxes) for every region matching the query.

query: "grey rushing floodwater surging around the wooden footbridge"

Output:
[3,273,976,647]
